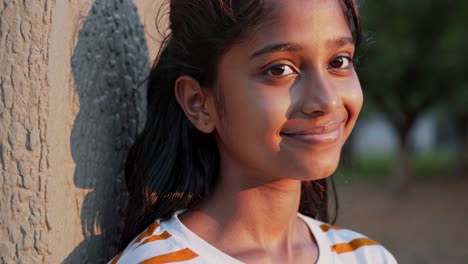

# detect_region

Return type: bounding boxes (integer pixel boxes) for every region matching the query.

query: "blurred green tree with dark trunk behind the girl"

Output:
[358,0,468,189]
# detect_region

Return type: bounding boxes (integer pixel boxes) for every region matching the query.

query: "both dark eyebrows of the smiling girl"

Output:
[249,37,355,59]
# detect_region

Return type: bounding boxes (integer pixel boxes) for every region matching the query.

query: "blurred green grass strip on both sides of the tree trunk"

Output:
[334,152,454,184]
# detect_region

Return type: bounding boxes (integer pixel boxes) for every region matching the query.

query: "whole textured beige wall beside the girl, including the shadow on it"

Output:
[0,0,161,263]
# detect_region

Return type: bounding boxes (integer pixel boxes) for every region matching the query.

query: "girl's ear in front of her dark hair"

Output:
[174,75,215,133]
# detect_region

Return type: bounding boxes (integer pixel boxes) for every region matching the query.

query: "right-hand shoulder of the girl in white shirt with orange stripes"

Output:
[299,214,397,264]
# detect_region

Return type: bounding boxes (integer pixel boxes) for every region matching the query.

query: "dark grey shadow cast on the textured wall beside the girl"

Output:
[63,0,149,263]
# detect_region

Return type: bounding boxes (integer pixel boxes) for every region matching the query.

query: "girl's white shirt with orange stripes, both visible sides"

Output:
[109,211,397,264]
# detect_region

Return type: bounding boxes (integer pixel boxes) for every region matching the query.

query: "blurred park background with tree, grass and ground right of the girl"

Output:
[334,0,468,263]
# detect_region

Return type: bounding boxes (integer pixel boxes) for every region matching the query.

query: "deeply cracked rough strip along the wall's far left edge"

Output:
[0,0,54,263]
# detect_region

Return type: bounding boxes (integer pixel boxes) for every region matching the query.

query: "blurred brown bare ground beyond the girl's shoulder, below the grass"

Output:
[337,177,468,264]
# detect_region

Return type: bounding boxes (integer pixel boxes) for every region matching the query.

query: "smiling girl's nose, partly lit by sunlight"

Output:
[300,73,342,115]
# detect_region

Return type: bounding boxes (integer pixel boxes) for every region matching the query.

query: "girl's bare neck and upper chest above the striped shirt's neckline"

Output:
[181,163,310,253]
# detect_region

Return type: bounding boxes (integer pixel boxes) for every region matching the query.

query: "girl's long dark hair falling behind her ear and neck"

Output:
[121,0,360,248]
